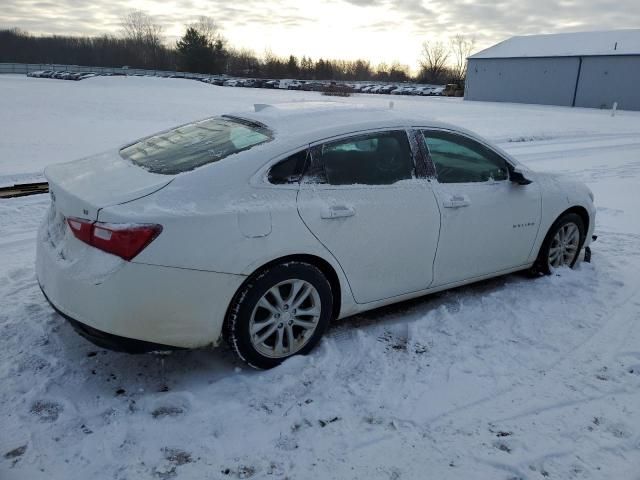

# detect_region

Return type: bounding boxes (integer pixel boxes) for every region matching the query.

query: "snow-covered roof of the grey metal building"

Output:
[469,29,640,58]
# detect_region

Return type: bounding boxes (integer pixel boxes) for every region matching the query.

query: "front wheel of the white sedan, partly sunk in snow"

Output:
[534,213,586,275]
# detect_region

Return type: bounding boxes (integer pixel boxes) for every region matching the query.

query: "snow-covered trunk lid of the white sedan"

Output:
[44,150,175,220]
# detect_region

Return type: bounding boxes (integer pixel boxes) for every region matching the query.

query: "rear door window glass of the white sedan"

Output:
[307,130,413,185]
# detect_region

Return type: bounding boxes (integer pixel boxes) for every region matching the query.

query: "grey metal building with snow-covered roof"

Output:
[465,30,640,110]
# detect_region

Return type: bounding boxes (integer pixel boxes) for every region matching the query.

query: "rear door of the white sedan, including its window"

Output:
[298,130,440,303]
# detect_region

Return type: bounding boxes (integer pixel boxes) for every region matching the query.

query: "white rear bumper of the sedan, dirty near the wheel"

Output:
[36,227,245,346]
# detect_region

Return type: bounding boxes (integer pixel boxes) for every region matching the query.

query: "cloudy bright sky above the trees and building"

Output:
[0,0,640,70]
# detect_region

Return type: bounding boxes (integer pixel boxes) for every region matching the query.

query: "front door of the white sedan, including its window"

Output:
[422,129,541,286]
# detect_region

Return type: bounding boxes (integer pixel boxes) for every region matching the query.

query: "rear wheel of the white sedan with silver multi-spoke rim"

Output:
[225,261,333,369]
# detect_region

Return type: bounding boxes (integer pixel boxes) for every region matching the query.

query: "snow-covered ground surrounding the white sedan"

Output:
[0,76,640,480]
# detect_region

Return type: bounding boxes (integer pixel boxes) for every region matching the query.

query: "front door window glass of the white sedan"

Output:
[422,130,509,183]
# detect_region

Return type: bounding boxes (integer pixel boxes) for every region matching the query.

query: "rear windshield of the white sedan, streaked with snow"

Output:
[120,117,273,175]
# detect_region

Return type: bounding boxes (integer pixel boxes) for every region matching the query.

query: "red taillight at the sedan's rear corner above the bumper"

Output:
[67,218,162,261]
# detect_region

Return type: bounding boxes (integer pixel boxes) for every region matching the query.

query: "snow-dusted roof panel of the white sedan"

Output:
[231,102,462,143]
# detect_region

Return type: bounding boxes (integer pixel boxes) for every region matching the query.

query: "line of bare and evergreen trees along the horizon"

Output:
[0,11,474,83]
